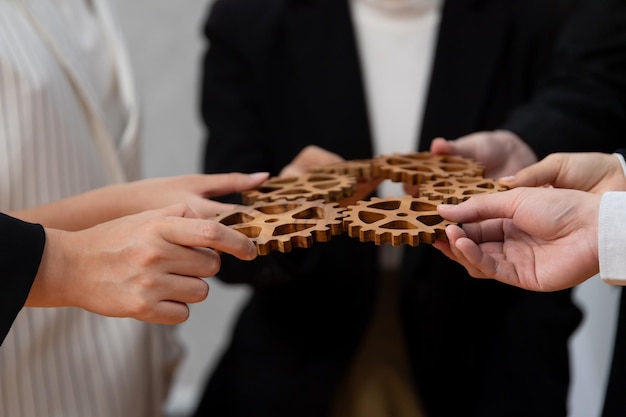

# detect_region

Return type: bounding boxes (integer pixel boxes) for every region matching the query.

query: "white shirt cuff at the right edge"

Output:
[598,191,626,285]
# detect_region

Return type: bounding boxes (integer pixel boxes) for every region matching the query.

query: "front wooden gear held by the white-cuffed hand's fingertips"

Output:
[343,195,455,246]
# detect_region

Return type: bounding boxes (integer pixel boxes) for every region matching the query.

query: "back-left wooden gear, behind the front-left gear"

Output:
[242,173,356,205]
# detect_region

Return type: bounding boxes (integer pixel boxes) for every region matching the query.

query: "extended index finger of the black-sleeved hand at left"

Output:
[161,217,257,260]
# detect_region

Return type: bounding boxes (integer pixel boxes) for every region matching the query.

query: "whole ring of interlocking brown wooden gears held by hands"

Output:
[222,152,506,255]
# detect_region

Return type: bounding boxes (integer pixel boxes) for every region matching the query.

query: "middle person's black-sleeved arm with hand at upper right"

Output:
[431,0,626,177]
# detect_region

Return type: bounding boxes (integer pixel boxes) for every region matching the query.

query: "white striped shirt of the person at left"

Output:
[0,0,180,417]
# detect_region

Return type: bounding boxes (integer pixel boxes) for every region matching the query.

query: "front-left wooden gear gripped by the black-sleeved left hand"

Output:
[215,198,344,255]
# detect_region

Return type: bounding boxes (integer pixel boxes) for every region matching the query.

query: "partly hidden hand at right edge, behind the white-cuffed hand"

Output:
[500,152,626,194]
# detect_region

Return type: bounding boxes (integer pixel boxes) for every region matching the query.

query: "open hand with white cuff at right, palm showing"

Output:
[428,188,601,291]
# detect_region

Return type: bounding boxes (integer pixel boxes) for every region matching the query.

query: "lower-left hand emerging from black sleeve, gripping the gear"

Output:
[26,205,257,324]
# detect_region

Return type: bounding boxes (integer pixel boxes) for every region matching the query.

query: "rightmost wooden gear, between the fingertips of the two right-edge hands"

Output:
[419,177,507,204]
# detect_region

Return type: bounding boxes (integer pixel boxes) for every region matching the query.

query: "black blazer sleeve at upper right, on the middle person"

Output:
[504,0,626,158]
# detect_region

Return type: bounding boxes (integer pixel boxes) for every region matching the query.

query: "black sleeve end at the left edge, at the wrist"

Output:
[0,213,46,344]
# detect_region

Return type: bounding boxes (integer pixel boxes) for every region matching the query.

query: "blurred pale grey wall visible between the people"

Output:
[113,0,618,417]
